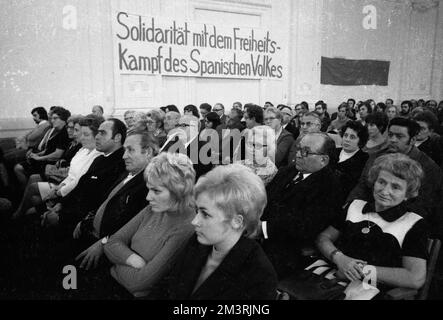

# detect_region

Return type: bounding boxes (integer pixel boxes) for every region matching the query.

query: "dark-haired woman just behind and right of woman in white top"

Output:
[362,112,389,155]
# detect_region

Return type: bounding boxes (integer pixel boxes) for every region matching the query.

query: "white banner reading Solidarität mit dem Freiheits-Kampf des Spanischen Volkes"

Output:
[113,12,284,80]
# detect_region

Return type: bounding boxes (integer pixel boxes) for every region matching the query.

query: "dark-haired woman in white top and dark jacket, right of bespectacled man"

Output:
[335,120,369,198]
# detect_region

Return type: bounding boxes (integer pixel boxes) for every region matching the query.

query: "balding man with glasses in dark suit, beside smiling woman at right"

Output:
[262,133,342,277]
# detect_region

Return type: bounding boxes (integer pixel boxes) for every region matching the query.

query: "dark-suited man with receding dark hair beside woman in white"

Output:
[43,119,126,235]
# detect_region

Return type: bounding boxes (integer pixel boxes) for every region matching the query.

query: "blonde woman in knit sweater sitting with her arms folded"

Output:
[104,153,195,297]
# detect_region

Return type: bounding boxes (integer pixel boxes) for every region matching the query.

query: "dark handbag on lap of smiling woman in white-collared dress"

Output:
[278,264,346,300]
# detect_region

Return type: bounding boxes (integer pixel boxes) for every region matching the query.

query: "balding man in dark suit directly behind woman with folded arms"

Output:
[74,132,159,270]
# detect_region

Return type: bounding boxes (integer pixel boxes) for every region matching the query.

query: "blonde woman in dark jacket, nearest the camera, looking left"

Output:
[168,164,277,300]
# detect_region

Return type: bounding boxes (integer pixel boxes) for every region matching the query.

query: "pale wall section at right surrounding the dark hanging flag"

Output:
[319,0,443,109]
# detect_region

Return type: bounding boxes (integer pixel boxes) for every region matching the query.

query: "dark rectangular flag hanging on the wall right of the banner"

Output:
[320,57,390,86]
